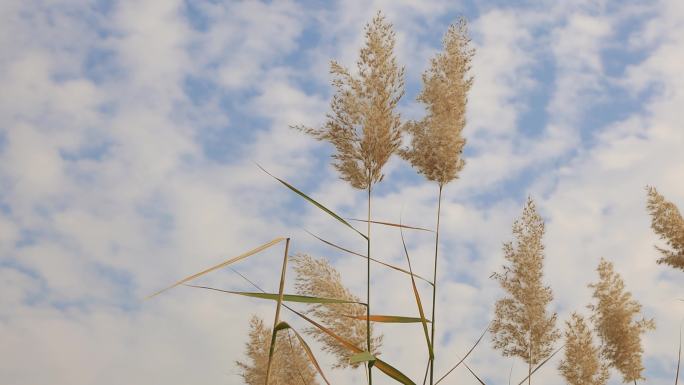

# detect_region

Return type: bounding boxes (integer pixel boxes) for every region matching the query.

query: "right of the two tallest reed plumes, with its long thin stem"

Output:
[399,18,474,384]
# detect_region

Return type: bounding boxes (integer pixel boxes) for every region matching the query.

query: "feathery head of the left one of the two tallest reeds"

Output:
[295,12,404,189]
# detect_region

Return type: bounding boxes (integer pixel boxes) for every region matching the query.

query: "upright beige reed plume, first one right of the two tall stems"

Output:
[491,198,560,384]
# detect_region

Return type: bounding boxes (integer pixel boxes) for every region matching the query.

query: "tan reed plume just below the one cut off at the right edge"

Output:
[588,258,655,383]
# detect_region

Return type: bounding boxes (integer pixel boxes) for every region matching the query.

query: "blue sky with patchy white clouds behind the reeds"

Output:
[0,0,684,385]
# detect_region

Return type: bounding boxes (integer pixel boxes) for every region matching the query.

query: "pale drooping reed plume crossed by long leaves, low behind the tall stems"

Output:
[292,254,382,368]
